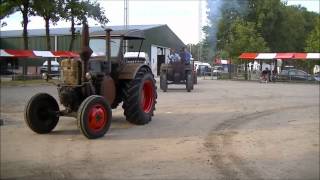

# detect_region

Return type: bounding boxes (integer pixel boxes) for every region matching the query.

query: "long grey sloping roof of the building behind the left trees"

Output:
[0,24,165,37]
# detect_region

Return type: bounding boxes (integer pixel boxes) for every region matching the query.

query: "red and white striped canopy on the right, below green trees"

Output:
[239,53,320,60]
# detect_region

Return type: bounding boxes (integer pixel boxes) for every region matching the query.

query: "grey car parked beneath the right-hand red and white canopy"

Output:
[278,69,315,81]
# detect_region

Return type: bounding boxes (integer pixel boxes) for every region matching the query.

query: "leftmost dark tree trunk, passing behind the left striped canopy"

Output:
[22,1,29,75]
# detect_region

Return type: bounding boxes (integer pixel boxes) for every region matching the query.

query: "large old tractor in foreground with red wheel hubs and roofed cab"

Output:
[25,24,157,139]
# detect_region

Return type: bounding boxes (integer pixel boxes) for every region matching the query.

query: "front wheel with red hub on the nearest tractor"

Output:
[77,95,112,139]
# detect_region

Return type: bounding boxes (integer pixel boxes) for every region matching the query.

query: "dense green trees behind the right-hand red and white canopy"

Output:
[203,0,320,67]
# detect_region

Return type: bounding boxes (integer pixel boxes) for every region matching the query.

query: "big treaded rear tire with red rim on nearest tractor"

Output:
[122,68,157,125]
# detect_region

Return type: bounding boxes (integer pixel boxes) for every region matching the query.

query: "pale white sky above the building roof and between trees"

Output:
[1,0,320,44]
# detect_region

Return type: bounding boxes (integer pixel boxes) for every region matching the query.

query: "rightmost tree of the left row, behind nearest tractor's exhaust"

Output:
[59,0,109,51]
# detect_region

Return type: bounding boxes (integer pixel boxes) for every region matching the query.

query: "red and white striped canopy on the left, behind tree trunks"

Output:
[0,49,79,58]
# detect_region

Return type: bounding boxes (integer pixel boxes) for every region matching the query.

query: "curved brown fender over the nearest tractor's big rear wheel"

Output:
[118,64,151,79]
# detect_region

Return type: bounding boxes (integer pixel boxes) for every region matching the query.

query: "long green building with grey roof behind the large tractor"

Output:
[0,24,185,74]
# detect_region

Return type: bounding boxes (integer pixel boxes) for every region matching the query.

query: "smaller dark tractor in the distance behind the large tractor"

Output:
[160,61,194,92]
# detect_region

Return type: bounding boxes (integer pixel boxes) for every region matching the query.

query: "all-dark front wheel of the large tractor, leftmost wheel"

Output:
[24,93,59,134]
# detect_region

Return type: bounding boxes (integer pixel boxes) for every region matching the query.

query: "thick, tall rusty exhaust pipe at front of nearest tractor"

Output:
[80,20,93,82]
